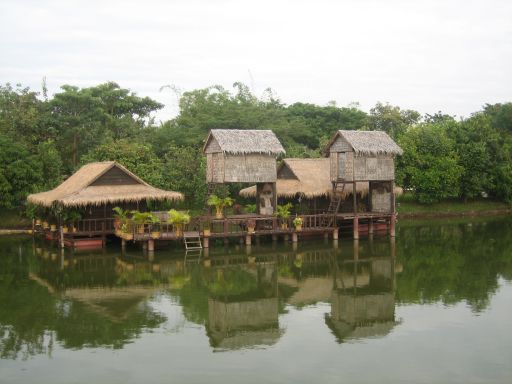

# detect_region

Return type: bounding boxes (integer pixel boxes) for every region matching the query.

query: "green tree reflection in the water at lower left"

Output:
[0,240,166,359]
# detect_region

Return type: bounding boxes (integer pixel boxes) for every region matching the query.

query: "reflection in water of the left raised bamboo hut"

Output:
[207,263,283,350]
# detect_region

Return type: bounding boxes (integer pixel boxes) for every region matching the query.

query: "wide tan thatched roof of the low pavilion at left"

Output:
[27,161,183,207]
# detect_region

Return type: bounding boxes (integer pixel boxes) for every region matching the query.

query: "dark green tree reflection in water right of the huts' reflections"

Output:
[397,218,512,312]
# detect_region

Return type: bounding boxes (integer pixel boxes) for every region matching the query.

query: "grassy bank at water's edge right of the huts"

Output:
[396,194,512,217]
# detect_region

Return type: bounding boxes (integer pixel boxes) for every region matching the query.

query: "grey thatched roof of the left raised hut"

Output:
[203,129,285,156]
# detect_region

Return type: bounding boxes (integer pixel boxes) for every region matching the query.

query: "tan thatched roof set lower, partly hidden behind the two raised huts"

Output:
[239,158,402,199]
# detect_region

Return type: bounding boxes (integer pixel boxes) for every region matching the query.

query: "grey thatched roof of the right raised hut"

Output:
[326,130,403,155]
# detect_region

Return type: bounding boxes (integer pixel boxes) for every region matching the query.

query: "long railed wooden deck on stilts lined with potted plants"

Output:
[36,212,394,248]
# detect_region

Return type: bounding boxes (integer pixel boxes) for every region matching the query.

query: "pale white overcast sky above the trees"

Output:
[0,0,512,119]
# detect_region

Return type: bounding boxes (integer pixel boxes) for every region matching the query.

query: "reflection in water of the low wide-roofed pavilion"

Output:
[30,250,161,323]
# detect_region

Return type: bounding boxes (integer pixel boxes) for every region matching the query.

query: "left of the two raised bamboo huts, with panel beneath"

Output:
[203,129,285,215]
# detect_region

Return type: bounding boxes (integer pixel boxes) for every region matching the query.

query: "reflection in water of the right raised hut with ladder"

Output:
[326,258,396,342]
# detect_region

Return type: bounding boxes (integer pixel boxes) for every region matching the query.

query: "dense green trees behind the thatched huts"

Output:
[0,82,512,213]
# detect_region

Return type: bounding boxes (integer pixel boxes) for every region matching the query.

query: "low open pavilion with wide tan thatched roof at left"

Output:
[27,161,183,247]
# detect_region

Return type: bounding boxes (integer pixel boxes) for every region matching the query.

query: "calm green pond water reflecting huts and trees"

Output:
[0,218,512,384]
